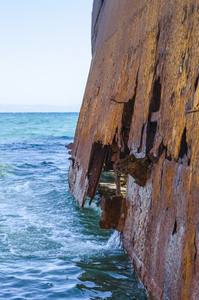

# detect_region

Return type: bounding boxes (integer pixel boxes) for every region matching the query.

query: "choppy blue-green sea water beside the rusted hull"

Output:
[0,113,147,300]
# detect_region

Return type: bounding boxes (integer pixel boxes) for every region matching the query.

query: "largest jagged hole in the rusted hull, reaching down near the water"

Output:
[98,95,135,231]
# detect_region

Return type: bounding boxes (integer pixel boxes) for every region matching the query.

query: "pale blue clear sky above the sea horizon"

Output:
[0,0,93,111]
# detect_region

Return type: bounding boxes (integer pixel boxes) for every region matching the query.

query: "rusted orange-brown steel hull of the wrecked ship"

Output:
[69,0,199,300]
